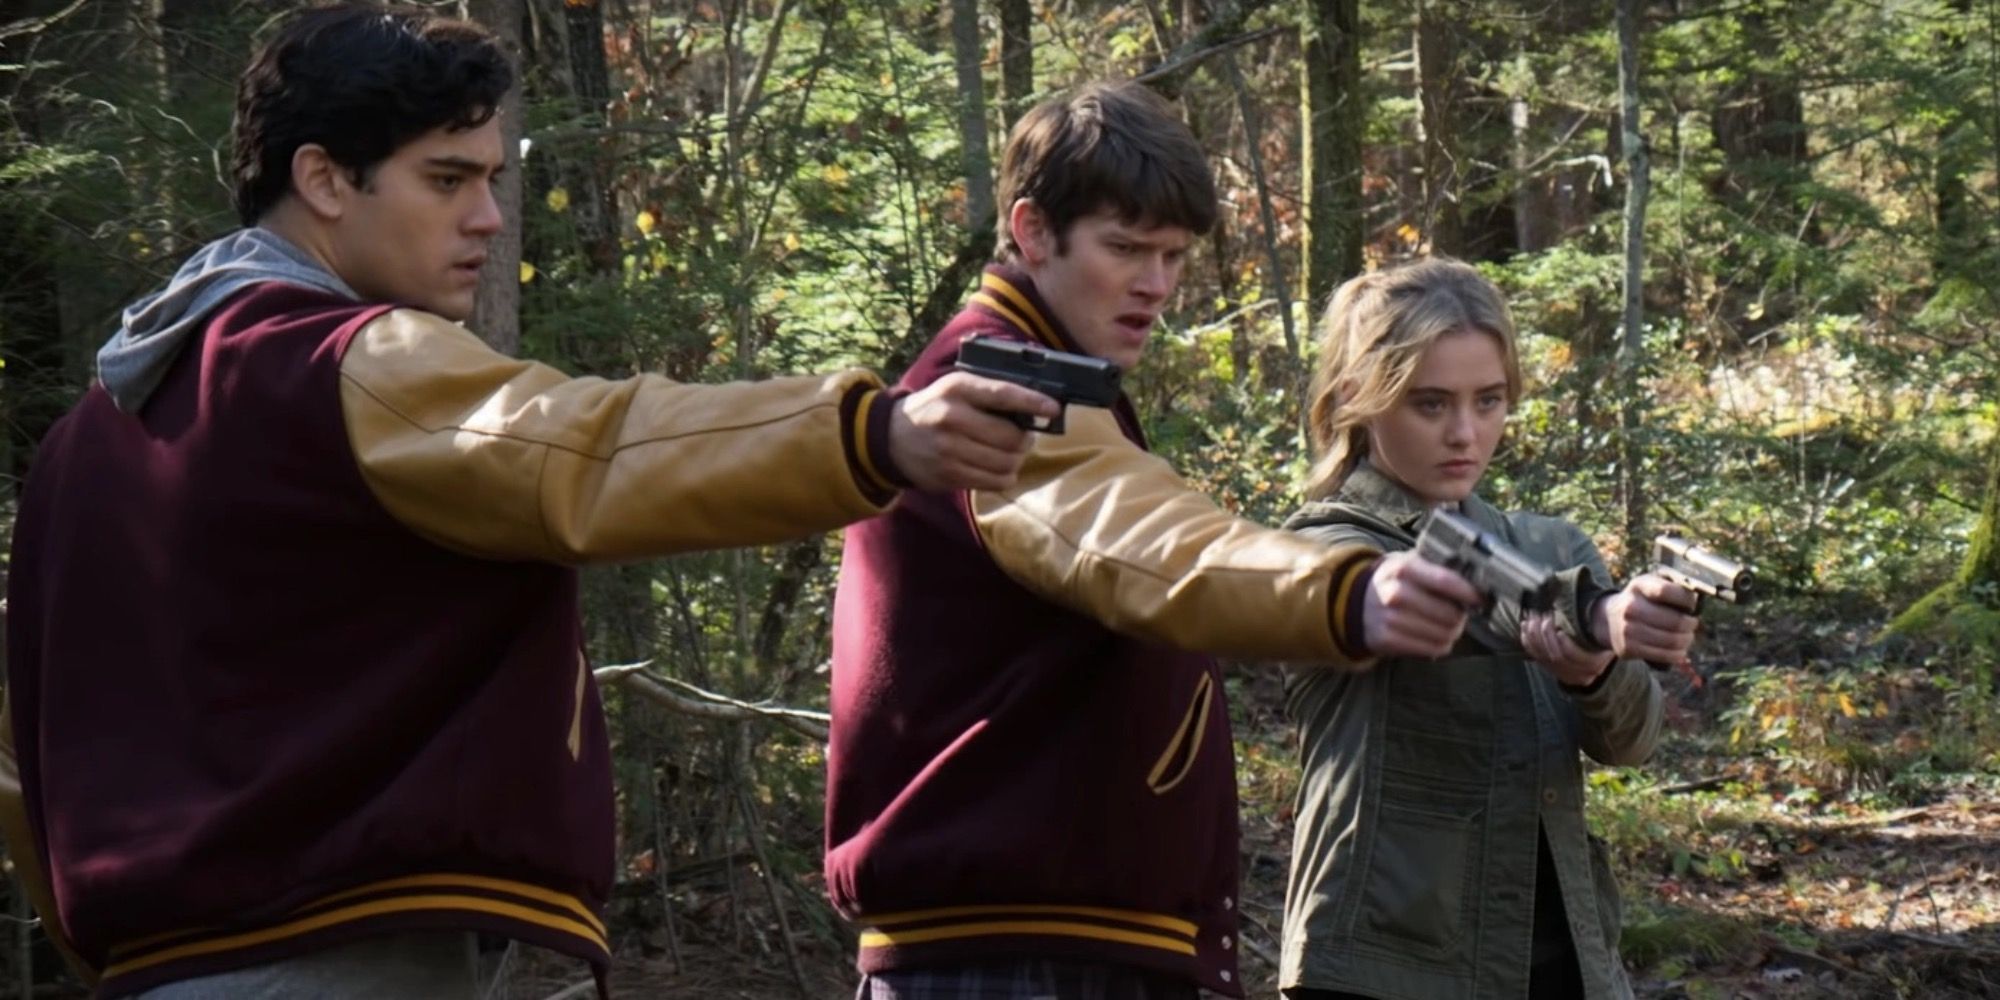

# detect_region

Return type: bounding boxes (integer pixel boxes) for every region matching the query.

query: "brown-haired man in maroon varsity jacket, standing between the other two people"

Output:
[826,84,1478,1000]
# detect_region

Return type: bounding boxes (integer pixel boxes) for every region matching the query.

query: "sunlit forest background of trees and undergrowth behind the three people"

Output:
[0,0,2000,998]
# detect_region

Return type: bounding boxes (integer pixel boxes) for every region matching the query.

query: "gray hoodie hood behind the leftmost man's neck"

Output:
[98,226,360,414]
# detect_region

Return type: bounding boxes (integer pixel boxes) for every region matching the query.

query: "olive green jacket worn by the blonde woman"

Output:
[1280,464,1664,1000]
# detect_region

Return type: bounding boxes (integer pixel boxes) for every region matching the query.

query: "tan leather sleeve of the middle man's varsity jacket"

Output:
[970,406,1378,664]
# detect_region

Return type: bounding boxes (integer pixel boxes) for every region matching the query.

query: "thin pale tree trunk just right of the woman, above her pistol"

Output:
[1616,0,1652,574]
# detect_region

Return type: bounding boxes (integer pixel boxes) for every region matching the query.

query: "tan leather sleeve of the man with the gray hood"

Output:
[340,310,894,562]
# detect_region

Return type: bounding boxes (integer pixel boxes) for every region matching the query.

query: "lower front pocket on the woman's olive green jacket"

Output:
[1356,802,1480,956]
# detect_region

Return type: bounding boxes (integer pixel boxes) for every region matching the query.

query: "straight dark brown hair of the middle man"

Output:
[996,82,1218,260]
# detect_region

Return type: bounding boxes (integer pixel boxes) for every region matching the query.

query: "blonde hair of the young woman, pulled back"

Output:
[1306,258,1520,500]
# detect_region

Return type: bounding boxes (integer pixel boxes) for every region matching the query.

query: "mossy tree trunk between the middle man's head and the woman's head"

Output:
[1300,0,1364,308]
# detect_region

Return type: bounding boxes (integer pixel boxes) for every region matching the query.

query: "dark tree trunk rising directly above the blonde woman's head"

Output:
[1416,0,1466,256]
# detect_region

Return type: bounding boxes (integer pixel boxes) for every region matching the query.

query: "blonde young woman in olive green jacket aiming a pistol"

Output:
[1282,260,1696,1000]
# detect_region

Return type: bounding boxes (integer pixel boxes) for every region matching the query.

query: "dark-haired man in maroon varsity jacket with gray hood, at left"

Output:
[4,4,1054,998]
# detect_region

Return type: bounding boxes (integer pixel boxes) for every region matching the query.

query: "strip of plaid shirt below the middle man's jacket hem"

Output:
[854,958,1204,1000]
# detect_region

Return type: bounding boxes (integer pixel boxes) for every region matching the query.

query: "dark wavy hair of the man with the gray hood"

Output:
[230,2,514,226]
